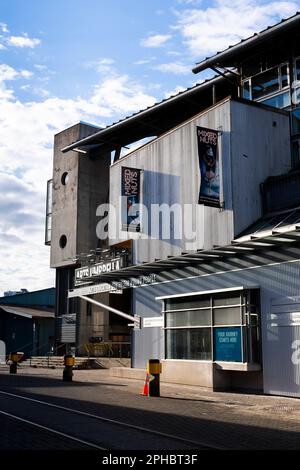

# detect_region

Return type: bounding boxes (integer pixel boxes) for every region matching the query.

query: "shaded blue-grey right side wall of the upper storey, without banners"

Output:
[231,101,291,236]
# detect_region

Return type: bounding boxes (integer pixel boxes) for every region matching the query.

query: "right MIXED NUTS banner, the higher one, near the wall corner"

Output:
[197,126,220,207]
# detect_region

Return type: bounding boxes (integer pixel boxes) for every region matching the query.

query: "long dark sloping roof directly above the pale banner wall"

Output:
[61,76,230,153]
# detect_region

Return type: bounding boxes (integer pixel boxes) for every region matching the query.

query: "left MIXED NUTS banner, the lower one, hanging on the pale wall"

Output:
[121,167,141,232]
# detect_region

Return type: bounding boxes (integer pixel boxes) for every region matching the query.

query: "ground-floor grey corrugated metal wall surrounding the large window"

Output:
[133,257,300,397]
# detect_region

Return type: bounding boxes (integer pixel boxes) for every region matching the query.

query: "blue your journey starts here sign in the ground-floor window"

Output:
[214,326,242,362]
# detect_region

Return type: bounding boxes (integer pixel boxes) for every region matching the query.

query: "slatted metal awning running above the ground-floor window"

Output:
[70,225,300,282]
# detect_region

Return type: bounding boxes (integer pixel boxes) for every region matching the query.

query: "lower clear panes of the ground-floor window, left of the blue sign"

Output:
[166,328,212,361]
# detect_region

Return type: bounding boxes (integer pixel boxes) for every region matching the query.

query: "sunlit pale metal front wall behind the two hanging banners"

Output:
[110,101,233,262]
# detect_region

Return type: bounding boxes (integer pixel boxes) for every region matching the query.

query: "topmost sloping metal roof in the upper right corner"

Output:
[192,11,300,73]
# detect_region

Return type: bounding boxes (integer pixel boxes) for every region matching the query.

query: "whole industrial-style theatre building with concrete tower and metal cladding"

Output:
[48,14,300,396]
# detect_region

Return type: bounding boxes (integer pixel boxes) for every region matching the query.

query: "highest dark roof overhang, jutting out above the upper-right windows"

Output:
[192,12,300,73]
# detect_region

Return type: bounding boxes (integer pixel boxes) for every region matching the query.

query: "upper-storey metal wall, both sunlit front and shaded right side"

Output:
[109,99,290,263]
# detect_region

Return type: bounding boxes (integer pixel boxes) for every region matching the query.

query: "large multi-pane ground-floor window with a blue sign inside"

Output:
[164,289,260,363]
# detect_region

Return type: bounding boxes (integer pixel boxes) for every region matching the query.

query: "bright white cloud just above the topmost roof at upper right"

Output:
[174,0,299,57]
